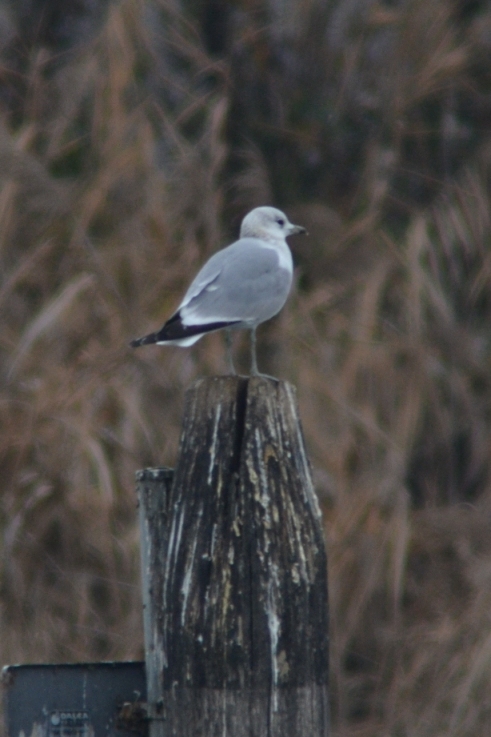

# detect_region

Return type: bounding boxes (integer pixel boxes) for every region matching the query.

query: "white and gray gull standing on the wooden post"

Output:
[130,207,307,376]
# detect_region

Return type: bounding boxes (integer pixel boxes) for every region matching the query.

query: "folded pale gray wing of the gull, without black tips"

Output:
[178,238,292,325]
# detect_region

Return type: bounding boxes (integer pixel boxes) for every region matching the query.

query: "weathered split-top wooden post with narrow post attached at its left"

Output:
[138,377,329,737]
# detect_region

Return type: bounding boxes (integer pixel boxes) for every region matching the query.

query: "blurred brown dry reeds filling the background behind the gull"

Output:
[0,0,491,737]
